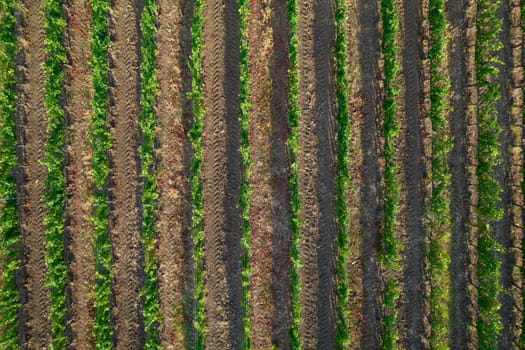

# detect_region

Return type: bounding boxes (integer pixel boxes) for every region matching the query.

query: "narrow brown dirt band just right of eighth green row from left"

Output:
[346,0,364,350]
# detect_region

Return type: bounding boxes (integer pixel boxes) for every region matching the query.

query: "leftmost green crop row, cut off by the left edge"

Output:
[0,0,21,349]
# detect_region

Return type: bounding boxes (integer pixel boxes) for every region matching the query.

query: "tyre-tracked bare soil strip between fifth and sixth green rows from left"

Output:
[202,0,242,349]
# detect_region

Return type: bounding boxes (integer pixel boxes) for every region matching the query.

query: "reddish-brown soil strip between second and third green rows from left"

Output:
[64,0,95,349]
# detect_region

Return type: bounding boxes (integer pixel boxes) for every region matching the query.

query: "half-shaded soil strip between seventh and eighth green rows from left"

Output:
[297,1,336,349]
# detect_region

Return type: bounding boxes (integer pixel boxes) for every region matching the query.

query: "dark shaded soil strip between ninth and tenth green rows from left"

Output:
[400,0,429,349]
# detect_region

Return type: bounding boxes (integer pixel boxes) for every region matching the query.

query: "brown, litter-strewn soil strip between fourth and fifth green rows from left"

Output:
[155,0,193,349]
